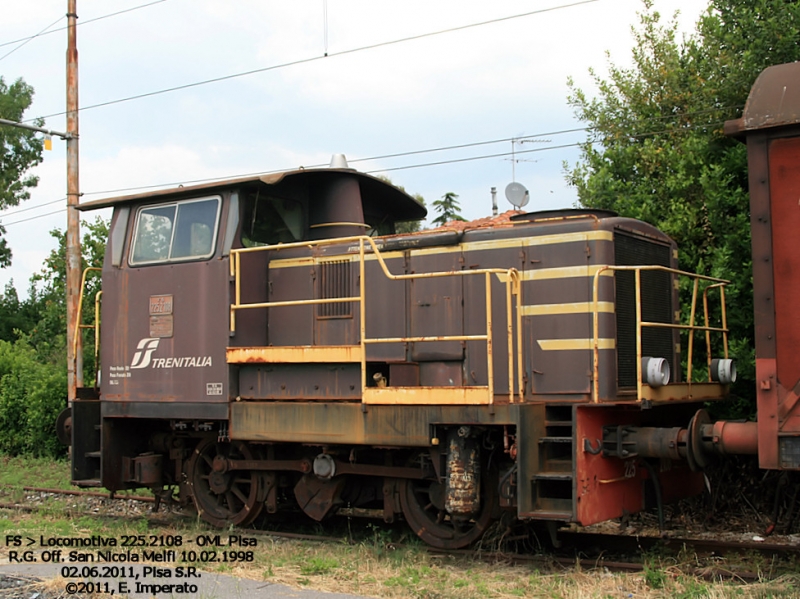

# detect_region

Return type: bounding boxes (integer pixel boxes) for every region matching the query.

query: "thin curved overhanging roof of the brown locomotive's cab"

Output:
[77,168,428,221]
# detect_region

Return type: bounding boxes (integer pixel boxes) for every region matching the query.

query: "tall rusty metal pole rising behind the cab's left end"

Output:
[66,0,83,403]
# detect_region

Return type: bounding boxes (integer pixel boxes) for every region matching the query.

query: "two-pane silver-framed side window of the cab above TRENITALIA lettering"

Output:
[130,197,220,265]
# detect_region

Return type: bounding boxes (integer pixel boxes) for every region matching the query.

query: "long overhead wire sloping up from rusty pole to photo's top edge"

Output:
[28,0,599,119]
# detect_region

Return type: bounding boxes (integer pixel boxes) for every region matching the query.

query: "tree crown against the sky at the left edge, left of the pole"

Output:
[0,77,44,268]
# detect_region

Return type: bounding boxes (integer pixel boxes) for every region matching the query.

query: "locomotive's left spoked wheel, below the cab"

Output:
[188,439,266,528]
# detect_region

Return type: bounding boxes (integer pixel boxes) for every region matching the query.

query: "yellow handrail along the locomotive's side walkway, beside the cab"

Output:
[230,235,524,403]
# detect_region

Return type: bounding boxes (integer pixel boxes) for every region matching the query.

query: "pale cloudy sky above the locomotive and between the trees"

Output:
[0,0,705,294]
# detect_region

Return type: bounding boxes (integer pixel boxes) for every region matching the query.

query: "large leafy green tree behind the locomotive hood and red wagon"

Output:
[567,0,800,412]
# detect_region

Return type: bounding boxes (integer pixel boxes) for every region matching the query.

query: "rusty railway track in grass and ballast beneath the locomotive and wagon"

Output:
[0,486,800,583]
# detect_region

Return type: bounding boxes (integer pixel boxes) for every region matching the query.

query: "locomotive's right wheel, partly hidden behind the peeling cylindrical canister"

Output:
[399,472,497,549]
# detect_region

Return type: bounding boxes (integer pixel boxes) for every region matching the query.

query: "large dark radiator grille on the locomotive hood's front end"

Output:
[614,231,678,387]
